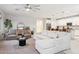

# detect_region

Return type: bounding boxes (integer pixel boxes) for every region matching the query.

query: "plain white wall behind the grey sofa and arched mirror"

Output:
[6,15,36,30]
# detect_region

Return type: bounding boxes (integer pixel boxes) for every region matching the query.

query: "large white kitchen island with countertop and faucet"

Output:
[33,31,71,54]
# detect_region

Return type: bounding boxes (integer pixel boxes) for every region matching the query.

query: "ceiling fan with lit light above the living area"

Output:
[16,4,40,12]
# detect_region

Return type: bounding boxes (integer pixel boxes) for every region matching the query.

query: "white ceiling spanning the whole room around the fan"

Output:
[0,4,79,17]
